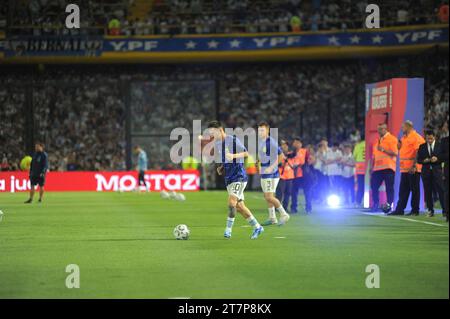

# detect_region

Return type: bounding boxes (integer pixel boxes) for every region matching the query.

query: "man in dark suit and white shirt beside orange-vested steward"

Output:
[417,130,445,217]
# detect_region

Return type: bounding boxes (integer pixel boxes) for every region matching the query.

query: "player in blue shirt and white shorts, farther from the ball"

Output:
[258,122,289,226]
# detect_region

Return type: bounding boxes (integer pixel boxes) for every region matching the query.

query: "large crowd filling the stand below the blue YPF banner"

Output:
[0,55,449,170]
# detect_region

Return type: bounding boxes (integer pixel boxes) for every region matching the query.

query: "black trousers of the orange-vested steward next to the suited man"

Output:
[395,173,420,213]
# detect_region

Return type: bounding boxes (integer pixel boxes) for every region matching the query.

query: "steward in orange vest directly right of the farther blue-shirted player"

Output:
[276,140,294,208]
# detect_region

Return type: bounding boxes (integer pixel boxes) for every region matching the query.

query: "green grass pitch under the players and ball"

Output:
[0,191,449,298]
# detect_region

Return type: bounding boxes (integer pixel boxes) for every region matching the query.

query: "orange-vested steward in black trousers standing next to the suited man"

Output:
[390,121,425,216]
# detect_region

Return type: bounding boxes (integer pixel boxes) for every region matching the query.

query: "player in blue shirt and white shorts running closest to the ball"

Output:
[208,121,264,239]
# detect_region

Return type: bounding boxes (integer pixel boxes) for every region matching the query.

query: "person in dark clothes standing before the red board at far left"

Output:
[25,142,48,204]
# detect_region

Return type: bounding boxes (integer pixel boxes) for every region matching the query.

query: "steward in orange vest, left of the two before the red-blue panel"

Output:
[370,123,398,211]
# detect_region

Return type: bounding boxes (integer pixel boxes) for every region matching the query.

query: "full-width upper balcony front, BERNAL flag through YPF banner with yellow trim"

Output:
[0,25,449,58]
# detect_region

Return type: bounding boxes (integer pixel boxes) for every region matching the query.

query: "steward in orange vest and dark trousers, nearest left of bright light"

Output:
[291,137,312,214]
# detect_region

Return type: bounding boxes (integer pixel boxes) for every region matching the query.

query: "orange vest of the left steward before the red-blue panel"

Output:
[372,132,398,172]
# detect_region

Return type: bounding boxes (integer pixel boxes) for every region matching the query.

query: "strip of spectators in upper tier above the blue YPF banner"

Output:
[4,0,448,35]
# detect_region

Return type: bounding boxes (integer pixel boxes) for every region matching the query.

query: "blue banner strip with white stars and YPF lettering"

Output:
[103,28,448,52]
